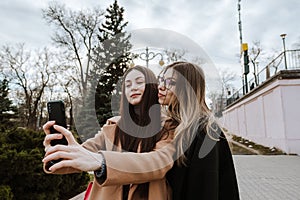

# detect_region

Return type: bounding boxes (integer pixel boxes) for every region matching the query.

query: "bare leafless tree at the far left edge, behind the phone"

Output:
[0,44,56,129]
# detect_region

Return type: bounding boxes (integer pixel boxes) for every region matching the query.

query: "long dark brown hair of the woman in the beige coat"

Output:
[114,65,162,199]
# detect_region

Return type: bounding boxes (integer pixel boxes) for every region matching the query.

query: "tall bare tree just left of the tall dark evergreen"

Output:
[43,3,104,101]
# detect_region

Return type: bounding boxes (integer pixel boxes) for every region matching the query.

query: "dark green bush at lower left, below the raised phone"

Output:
[0,128,90,200]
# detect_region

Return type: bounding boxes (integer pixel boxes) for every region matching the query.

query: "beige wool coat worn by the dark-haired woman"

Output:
[83,117,175,200]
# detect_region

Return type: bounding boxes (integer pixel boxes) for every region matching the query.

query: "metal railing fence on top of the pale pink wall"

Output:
[226,49,300,106]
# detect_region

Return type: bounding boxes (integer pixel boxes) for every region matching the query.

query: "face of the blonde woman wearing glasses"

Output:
[158,68,176,105]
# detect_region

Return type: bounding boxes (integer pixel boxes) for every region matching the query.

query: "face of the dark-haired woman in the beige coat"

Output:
[125,70,146,105]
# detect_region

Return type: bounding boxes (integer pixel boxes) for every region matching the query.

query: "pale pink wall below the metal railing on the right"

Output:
[222,72,300,155]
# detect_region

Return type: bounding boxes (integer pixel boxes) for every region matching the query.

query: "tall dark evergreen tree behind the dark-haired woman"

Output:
[95,0,132,125]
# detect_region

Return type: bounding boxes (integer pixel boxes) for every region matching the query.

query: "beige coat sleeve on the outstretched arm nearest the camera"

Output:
[98,136,175,186]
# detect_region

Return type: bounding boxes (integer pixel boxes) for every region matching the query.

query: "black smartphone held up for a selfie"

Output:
[45,100,68,171]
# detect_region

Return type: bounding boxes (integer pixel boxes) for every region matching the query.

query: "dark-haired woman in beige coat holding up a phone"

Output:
[43,66,174,200]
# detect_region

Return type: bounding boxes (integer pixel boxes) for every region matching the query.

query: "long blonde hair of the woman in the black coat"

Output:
[162,62,217,164]
